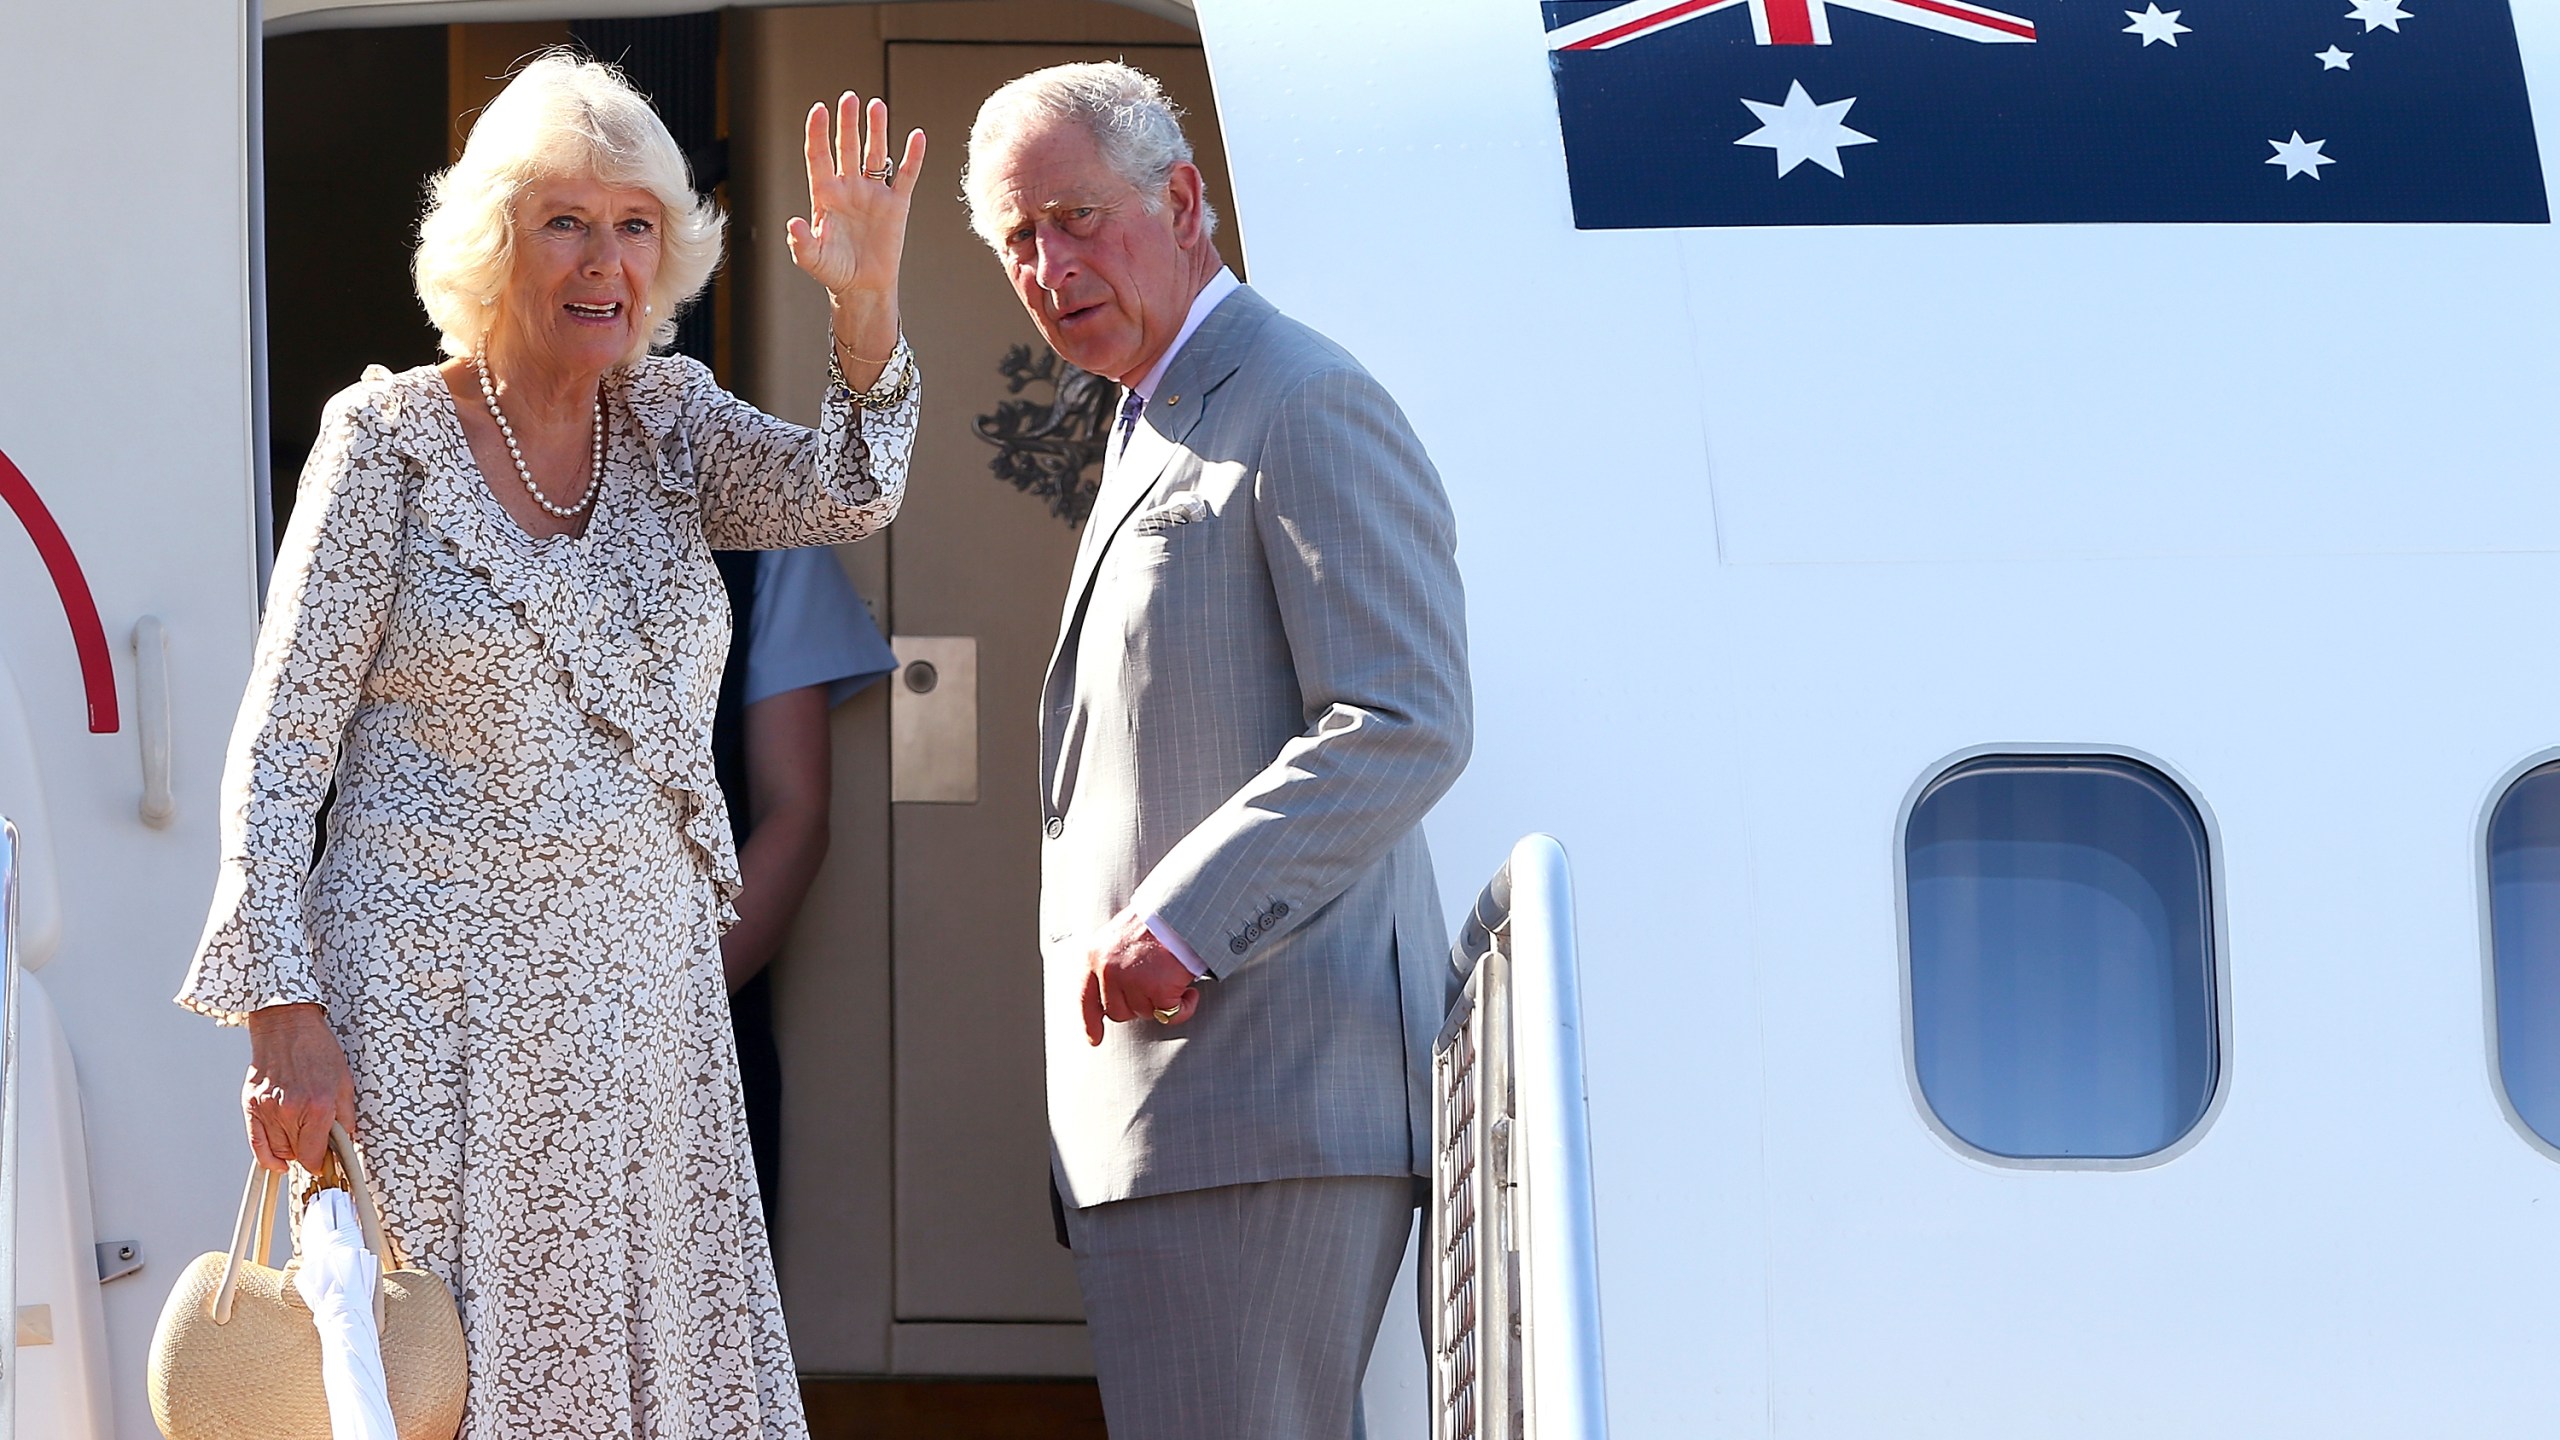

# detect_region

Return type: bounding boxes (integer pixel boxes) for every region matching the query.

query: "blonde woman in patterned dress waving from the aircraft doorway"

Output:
[179,54,924,1440]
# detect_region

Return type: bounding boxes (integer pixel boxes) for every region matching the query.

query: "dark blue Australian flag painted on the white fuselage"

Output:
[1544,0,2550,231]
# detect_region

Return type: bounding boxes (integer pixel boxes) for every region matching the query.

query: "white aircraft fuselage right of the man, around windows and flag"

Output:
[1203,0,2560,1440]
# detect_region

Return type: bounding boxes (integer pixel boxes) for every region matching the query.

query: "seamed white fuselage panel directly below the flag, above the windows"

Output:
[1679,225,2560,564]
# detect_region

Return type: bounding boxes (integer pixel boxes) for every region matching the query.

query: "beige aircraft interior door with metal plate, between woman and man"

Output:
[727,14,1242,1383]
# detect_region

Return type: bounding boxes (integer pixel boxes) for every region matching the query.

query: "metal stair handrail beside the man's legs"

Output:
[1428,835,1608,1440]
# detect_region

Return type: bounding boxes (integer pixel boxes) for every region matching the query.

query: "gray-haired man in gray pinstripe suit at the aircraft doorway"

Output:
[965,64,1472,1440]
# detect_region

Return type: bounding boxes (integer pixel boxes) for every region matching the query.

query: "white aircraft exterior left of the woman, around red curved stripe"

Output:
[0,0,256,1440]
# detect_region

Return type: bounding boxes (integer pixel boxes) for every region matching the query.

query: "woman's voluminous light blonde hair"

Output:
[410,49,727,364]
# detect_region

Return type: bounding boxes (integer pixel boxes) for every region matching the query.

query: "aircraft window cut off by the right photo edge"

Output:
[2488,761,2560,1145]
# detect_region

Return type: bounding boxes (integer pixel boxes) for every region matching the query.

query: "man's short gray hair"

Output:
[960,59,1219,249]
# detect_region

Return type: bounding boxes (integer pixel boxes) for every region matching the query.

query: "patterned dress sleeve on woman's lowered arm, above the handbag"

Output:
[177,374,402,1025]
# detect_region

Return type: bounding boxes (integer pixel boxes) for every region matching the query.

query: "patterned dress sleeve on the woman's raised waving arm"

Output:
[686,336,924,551]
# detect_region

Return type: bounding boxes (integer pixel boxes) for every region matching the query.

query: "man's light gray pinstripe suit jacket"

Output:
[1039,287,1475,1207]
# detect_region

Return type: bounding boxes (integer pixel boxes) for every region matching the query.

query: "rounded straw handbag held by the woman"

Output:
[151,1125,466,1440]
